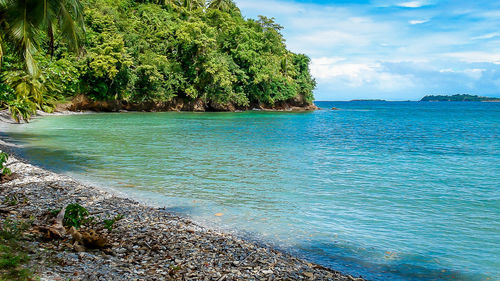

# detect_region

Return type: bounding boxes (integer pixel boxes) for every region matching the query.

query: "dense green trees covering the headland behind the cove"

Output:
[0,0,315,119]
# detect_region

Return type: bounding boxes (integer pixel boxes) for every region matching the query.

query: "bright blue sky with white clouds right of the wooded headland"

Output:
[235,0,500,100]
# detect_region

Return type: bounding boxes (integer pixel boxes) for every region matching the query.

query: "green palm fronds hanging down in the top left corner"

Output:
[0,0,83,75]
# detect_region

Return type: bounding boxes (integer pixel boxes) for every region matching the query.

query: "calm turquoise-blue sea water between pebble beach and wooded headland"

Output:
[0,102,500,280]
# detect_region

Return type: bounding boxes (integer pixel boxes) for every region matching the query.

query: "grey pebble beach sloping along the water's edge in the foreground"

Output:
[0,125,364,281]
